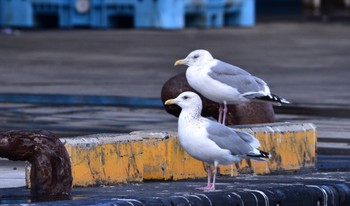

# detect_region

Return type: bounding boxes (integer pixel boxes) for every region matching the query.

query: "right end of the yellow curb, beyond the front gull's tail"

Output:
[221,123,317,174]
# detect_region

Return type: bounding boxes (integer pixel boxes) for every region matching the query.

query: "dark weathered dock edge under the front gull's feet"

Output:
[0,172,350,206]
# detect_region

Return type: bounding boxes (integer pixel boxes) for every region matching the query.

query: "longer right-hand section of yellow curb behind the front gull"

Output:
[136,123,317,180]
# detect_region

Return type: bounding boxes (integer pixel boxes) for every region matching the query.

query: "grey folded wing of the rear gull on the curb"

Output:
[208,61,267,94]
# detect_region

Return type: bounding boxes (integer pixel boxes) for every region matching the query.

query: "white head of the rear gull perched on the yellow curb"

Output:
[175,49,214,66]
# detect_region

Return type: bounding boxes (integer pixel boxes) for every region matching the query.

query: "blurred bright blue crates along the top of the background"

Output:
[0,0,255,29]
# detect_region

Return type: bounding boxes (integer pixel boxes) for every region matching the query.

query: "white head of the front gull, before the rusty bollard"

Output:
[164,92,202,113]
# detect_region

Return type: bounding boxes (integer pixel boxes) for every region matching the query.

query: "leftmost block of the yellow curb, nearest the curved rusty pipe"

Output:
[61,134,143,186]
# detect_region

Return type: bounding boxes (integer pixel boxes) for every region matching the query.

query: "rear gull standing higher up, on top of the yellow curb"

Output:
[175,49,289,124]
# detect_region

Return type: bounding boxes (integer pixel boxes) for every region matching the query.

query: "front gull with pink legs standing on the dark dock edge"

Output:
[165,92,270,190]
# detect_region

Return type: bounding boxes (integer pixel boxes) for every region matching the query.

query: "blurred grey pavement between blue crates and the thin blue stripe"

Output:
[0,22,350,105]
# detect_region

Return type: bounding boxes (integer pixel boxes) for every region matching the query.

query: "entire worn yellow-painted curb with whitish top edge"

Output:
[24,123,317,186]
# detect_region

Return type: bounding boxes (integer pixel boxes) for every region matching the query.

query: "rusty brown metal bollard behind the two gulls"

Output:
[161,72,275,125]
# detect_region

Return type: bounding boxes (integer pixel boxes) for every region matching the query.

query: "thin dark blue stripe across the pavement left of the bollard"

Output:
[0,93,163,108]
